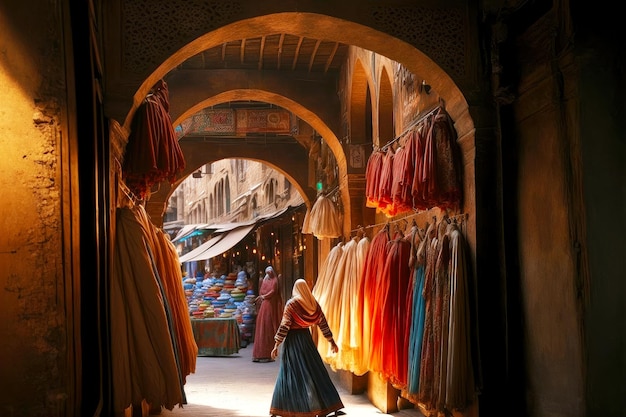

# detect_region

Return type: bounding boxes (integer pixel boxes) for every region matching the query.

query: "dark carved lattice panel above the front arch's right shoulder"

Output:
[372,6,467,78]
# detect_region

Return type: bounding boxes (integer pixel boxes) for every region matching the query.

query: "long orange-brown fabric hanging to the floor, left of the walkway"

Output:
[109,206,186,413]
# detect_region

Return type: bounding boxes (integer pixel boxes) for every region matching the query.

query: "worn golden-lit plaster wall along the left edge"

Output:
[0,0,73,417]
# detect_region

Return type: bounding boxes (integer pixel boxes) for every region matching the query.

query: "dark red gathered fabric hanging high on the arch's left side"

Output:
[122,80,185,199]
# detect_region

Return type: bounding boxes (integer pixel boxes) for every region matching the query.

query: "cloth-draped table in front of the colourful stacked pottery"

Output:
[191,318,241,356]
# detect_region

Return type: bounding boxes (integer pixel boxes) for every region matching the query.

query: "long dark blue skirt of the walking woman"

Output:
[270,329,344,417]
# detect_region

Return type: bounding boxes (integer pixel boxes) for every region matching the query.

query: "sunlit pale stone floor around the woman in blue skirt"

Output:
[160,345,423,417]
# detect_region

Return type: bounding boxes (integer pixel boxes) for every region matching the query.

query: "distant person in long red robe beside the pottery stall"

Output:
[252,265,283,362]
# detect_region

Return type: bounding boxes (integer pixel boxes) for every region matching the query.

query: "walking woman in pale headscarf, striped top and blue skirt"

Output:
[270,279,344,417]
